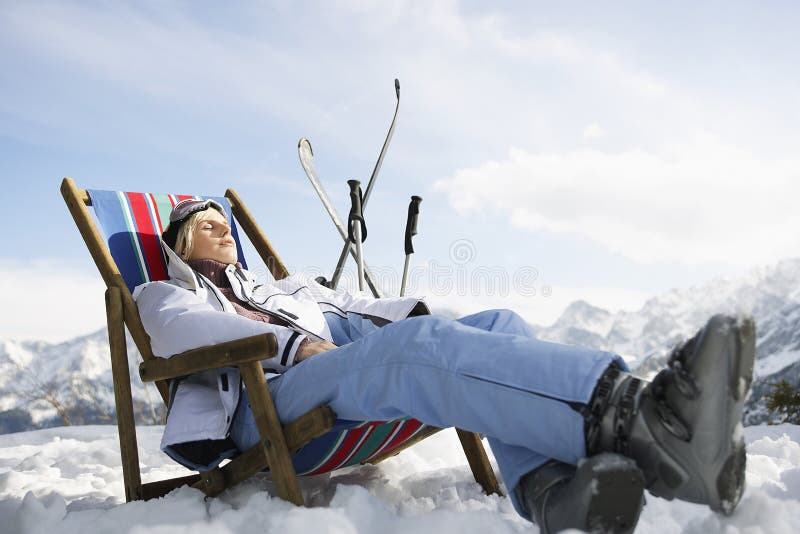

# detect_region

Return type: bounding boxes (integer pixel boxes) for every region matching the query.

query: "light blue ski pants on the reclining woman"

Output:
[231,310,627,512]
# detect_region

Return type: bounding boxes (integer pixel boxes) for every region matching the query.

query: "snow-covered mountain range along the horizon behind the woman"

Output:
[0,258,800,433]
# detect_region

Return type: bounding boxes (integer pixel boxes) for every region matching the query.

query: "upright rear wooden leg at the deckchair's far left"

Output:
[106,287,142,502]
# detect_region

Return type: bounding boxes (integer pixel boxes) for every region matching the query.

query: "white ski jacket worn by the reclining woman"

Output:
[133,245,424,457]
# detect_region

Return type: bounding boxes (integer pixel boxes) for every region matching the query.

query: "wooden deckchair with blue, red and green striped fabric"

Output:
[61,178,501,505]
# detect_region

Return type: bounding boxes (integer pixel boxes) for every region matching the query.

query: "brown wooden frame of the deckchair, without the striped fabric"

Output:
[61,178,501,505]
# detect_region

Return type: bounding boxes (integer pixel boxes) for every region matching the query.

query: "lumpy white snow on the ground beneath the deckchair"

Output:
[0,425,800,534]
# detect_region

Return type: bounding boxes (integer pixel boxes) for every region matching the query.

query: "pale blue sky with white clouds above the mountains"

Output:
[0,2,800,339]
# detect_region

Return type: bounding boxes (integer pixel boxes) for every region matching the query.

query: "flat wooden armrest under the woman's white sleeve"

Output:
[139,334,278,382]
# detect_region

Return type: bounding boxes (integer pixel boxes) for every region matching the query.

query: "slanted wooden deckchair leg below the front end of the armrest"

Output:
[239,362,305,506]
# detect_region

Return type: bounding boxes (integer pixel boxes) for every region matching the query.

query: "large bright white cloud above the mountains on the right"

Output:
[435,134,800,265]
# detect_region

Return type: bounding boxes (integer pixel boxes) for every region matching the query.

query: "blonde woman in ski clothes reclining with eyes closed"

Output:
[134,200,755,532]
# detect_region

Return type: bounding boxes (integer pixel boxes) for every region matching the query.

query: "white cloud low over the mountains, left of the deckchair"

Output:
[0,258,106,342]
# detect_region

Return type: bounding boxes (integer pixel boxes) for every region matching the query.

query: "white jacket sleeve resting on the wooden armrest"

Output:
[134,282,306,372]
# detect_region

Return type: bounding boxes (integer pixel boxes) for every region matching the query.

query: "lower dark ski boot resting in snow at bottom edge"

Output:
[517,453,644,534]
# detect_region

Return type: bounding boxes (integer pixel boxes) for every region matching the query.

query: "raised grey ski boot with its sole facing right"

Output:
[587,315,755,514]
